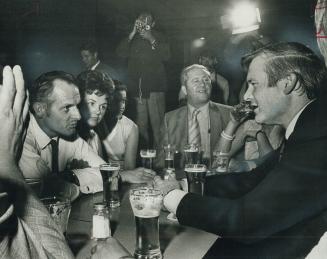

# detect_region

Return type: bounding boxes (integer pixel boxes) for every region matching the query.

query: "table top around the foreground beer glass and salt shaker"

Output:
[67,185,217,259]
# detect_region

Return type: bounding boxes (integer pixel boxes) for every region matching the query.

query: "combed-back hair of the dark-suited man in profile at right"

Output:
[242,42,327,99]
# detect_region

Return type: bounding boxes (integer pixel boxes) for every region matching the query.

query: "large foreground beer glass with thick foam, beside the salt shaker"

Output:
[129,187,163,259]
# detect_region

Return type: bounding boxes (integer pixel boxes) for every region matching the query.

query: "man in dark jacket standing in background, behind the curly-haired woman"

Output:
[80,42,120,79]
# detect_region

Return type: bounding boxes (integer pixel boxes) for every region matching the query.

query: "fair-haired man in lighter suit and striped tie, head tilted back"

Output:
[156,64,230,172]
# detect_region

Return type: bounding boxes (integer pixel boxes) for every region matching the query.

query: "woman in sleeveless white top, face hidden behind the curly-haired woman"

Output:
[99,81,139,170]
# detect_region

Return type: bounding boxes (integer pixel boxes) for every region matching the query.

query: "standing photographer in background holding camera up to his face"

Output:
[117,13,170,148]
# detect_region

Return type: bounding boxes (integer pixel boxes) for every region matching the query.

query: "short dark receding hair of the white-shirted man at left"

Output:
[30,71,76,107]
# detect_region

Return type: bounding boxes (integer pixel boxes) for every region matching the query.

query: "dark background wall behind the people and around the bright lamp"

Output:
[0,0,319,109]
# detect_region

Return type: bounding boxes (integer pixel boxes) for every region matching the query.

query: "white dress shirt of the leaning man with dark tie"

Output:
[19,114,105,193]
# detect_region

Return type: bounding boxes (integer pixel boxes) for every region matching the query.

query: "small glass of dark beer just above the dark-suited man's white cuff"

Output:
[184,164,207,195]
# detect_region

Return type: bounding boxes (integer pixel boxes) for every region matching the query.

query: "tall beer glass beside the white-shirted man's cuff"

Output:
[100,162,120,208]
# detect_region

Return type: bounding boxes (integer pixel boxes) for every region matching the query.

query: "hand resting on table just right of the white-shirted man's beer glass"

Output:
[120,167,156,183]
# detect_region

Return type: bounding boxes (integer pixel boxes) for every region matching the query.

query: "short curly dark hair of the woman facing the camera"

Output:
[77,70,115,102]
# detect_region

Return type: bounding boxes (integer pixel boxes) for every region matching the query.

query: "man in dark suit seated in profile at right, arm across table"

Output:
[156,43,327,259]
